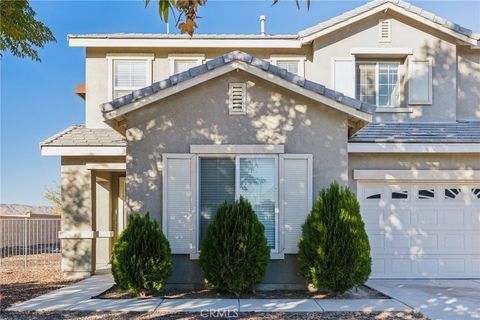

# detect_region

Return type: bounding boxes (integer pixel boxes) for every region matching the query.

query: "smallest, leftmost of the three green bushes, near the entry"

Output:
[112,213,172,295]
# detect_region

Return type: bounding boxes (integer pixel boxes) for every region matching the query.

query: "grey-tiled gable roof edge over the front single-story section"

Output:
[100,51,375,122]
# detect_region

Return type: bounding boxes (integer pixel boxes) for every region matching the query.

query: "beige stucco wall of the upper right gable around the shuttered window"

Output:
[307,11,456,121]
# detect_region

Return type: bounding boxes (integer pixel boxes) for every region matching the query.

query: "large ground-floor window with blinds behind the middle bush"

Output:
[198,155,278,251]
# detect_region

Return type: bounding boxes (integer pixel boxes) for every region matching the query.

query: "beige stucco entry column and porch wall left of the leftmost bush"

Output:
[61,157,125,278]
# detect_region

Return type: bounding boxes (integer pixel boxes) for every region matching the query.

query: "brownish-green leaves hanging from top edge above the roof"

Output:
[144,0,310,36]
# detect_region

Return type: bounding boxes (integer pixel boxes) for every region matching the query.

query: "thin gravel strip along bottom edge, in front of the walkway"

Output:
[1,312,427,320]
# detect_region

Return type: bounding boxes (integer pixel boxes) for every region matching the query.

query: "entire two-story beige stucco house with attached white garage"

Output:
[41,0,480,288]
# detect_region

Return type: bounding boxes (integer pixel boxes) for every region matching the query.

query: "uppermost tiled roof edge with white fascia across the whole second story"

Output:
[68,0,480,48]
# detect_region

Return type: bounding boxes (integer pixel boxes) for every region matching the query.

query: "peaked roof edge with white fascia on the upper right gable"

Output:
[298,0,480,45]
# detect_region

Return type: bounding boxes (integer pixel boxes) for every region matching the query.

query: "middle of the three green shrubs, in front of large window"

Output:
[200,198,270,296]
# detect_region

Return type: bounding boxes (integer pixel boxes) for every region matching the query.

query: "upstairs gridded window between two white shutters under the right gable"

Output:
[356,62,400,107]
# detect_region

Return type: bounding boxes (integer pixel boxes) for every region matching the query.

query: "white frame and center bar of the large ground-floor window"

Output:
[190,153,284,255]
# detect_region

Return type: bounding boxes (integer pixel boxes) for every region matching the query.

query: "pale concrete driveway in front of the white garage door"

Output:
[367,280,480,320]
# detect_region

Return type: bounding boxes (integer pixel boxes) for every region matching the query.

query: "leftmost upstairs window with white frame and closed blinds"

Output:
[107,55,153,100]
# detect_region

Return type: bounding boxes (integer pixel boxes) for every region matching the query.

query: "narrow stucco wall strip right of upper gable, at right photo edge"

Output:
[457,47,480,121]
